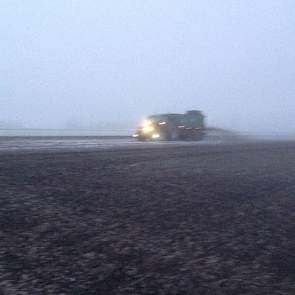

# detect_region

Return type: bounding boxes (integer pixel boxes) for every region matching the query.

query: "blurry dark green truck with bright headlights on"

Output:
[133,110,206,141]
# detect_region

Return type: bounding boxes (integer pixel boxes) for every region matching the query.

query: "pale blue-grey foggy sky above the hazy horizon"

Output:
[0,0,295,132]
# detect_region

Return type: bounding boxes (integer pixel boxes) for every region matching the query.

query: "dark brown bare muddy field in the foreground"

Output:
[0,142,295,295]
